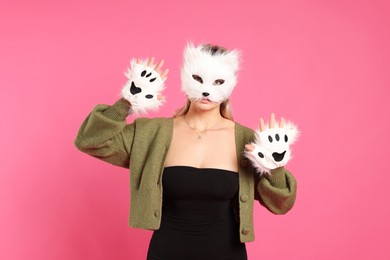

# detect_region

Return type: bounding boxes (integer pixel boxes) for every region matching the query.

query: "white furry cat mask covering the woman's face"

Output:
[181,43,239,103]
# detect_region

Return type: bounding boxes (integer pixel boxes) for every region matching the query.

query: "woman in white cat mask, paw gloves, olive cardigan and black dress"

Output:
[75,44,296,260]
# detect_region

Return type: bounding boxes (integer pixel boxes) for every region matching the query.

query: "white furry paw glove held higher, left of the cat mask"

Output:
[122,60,164,114]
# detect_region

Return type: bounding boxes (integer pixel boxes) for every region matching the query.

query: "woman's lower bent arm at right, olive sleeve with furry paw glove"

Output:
[245,113,298,214]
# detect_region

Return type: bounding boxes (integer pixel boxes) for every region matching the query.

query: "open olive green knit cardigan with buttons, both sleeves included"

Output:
[74,99,296,242]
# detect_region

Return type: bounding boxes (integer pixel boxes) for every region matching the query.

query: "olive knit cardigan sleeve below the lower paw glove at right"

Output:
[255,167,297,215]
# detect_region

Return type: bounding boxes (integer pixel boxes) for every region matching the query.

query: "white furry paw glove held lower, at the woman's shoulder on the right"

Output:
[245,122,298,174]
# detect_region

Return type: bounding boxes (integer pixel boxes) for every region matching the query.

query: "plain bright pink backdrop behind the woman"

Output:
[0,0,390,260]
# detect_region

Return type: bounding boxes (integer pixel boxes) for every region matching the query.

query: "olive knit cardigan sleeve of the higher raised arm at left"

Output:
[74,98,136,168]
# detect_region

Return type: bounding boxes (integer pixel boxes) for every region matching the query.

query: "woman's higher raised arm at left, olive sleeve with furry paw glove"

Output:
[74,58,168,168]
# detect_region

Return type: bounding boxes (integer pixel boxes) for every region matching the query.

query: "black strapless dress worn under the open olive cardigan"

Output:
[147,166,247,260]
